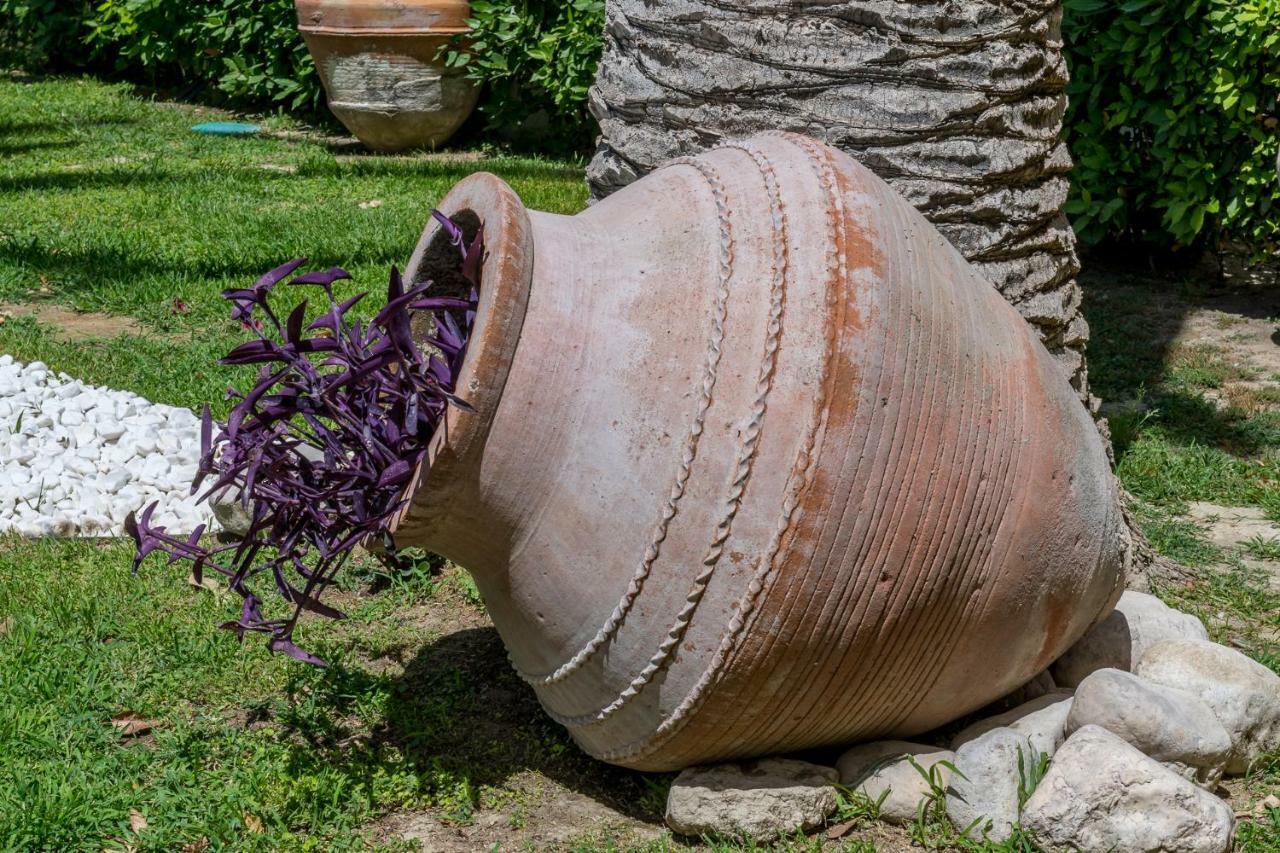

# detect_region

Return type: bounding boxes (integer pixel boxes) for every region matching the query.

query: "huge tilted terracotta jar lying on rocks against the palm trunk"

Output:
[386,134,1123,770]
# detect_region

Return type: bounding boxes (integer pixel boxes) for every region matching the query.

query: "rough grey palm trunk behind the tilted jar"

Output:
[588,0,1097,410]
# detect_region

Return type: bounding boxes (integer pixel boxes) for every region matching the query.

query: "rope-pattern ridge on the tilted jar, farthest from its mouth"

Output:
[599,132,847,761]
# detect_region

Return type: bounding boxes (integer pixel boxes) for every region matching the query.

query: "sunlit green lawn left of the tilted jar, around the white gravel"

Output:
[0,78,650,850]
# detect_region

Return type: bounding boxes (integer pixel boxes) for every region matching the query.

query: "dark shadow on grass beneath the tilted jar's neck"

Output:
[279,628,662,821]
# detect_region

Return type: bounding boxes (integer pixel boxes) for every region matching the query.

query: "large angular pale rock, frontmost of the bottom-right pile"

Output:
[1023,726,1234,853]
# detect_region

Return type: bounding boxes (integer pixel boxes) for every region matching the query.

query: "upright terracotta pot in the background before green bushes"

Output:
[294,0,477,151]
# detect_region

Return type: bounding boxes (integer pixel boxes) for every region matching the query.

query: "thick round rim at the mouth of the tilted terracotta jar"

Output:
[389,172,534,542]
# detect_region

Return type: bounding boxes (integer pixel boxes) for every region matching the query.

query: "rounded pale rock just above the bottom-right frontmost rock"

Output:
[1066,669,1231,790]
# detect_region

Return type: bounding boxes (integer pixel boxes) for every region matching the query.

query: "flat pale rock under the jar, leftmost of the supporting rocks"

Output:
[667,758,837,841]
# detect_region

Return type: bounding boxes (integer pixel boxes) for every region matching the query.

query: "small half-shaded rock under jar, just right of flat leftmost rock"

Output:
[836,740,955,824]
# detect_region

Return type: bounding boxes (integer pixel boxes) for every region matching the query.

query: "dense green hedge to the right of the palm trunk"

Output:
[1064,0,1280,252]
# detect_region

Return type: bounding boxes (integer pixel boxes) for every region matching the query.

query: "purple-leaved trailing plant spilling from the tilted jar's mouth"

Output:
[125,210,484,666]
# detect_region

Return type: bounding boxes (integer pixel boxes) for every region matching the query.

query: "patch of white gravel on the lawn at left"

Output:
[0,355,212,537]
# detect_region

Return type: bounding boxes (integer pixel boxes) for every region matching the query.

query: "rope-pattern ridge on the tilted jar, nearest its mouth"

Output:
[507,158,735,686]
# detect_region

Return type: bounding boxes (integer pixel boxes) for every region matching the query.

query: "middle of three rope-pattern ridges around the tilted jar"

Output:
[549,143,791,726]
